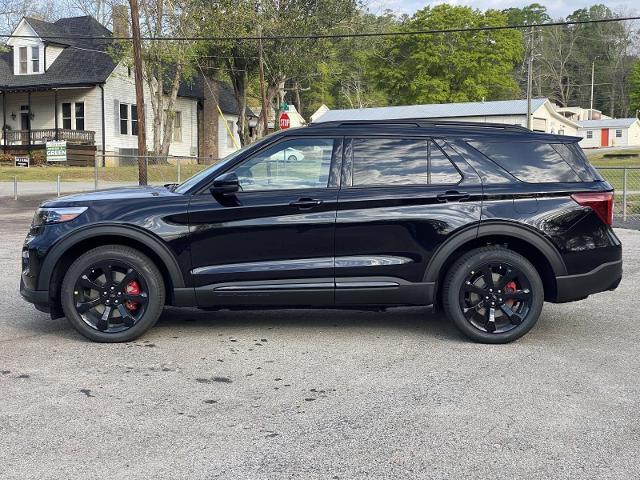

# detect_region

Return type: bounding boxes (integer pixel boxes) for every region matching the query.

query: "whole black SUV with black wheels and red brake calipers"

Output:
[20,120,622,343]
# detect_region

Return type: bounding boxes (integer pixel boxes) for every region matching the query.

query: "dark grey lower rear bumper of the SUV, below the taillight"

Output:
[554,260,622,303]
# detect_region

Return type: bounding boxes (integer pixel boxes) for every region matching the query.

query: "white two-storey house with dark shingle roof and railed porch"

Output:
[0,16,245,163]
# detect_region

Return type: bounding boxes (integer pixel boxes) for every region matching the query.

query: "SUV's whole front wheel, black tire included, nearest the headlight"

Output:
[60,245,165,342]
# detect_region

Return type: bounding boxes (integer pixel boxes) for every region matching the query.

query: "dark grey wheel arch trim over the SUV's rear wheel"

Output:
[424,221,567,300]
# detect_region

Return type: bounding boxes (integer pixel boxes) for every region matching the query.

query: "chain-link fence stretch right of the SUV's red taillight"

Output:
[598,166,640,229]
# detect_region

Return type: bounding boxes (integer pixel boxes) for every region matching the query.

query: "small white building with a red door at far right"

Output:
[578,118,640,148]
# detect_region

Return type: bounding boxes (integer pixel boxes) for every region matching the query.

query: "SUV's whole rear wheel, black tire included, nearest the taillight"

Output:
[442,246,544,344]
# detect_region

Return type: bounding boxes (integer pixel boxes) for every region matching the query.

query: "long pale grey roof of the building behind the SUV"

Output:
[316,98,547,123]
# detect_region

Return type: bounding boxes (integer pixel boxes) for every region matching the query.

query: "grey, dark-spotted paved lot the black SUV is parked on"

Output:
[0,202,640,479]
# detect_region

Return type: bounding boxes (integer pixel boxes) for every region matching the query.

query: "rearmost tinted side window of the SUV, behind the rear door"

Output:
[469,141,580,183]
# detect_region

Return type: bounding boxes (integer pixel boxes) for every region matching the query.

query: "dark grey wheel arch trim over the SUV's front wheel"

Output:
[38,225,184,315]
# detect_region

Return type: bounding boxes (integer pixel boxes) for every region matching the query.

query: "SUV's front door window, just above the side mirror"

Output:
[235,138,334,191]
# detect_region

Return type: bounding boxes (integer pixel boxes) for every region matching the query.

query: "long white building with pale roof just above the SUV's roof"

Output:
[314,98,579,135]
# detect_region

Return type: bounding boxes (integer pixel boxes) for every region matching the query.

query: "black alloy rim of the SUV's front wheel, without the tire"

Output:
[73,260,149,333]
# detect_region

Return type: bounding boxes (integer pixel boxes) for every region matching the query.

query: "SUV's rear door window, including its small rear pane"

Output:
[353,138,462,186]
